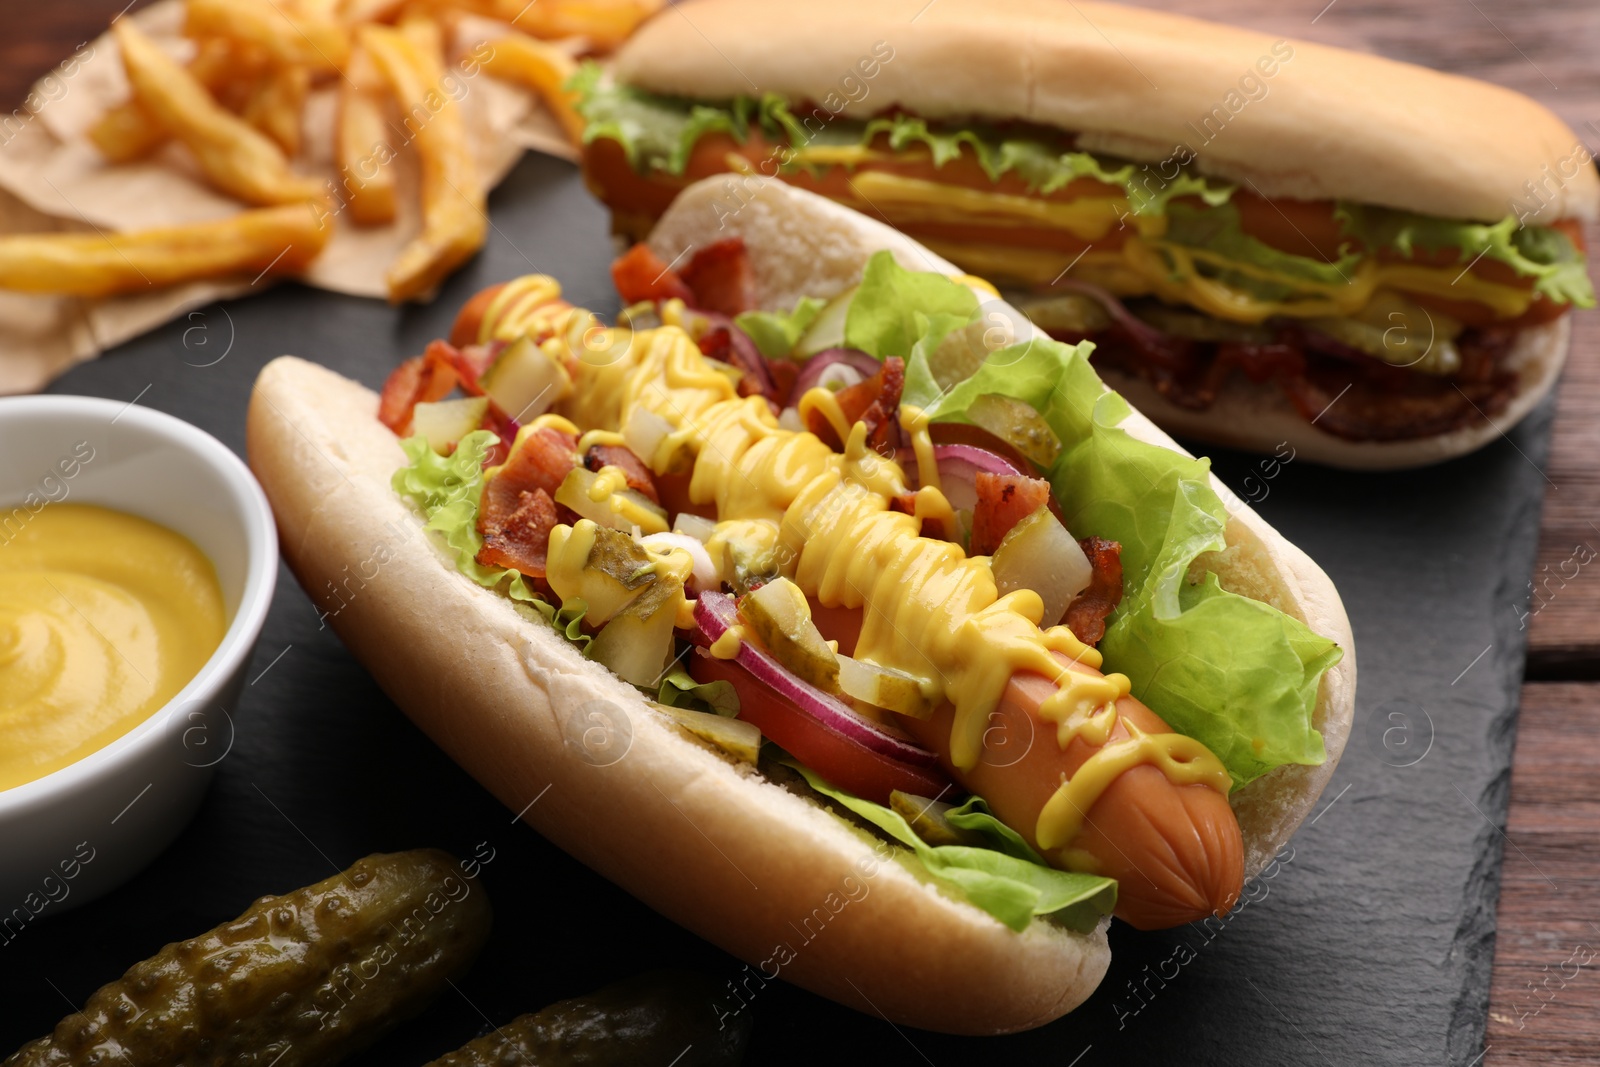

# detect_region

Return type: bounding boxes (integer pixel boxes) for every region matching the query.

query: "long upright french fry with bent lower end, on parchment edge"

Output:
[360,21,488,302]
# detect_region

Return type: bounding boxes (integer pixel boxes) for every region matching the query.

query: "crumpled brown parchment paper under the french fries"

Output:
[0,0,584,394]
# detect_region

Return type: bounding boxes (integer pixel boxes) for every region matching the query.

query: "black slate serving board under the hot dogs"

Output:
[0,151,1550,1067]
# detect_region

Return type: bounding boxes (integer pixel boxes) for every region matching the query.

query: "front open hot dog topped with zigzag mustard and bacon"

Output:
[250,177,1354,1032]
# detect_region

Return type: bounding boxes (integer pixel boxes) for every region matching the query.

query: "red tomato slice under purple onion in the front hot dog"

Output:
[690,648,950,805]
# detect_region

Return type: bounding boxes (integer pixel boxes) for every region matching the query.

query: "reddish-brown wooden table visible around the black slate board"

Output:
[0,0,1600,1067]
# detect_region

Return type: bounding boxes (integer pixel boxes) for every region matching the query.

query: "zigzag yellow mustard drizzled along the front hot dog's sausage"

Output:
[486,278,1230,869]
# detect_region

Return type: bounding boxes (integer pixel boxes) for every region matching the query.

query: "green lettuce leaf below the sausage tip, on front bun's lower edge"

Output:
[787,760,1117,933]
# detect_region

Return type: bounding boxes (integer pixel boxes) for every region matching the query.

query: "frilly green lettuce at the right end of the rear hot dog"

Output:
[1336,203,1595,307]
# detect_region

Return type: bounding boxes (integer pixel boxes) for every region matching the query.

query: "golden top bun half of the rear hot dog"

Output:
[616,0,1600,222]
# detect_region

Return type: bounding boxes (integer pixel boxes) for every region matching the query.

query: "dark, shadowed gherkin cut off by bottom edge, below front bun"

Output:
[429,971,754,1067]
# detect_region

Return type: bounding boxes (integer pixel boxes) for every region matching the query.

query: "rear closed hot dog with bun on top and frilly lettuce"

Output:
[578,0,1600,467]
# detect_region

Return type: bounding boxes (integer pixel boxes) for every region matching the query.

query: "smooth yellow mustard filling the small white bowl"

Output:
[0,504,226,789]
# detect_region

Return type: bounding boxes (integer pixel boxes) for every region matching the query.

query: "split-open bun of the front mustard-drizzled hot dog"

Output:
[248,177,1355,1033]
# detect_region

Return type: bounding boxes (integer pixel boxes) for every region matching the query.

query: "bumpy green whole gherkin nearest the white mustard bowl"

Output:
[3,849,491,1067]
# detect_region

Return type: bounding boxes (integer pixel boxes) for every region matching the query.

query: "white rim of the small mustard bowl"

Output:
[0,394,278,819]
